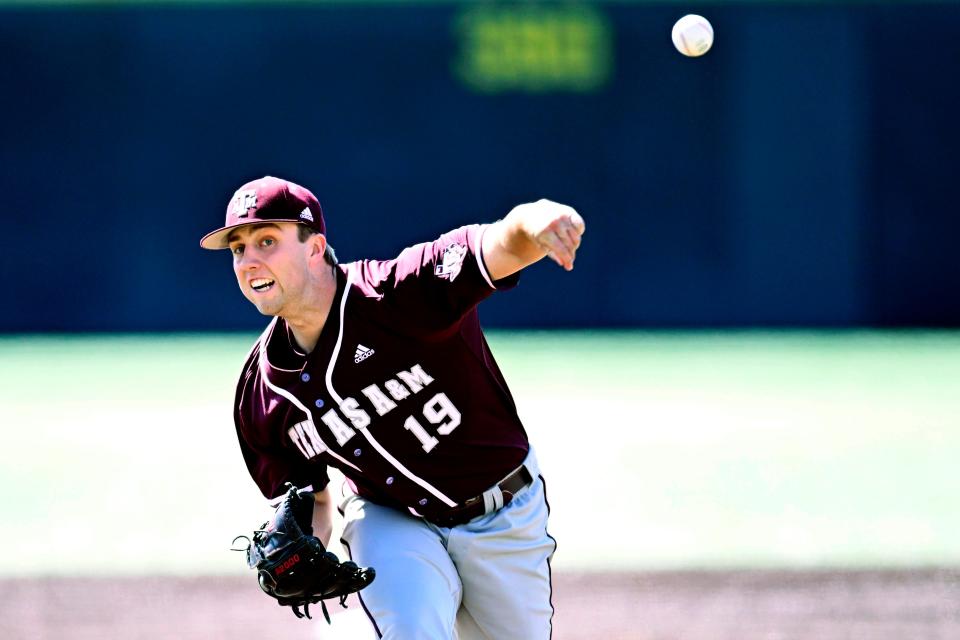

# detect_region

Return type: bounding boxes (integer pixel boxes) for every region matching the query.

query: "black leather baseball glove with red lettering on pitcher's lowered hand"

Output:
[233,483,376,622]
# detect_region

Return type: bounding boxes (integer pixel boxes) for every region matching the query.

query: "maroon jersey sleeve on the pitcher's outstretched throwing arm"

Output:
[358,225,520,333]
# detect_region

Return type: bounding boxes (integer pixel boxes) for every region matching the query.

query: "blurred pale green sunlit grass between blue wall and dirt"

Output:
[0,331,960,575]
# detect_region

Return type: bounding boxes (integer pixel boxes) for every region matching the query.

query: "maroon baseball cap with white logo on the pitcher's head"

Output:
[200,176,327,249]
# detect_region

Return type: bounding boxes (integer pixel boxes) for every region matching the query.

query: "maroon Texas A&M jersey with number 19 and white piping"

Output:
[234,225,528,517]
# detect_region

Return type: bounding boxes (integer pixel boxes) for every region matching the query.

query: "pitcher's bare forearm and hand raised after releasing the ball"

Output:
[482,200,585,281]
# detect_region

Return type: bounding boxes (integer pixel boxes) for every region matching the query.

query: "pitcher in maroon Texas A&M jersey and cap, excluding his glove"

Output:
[201,176,584,640]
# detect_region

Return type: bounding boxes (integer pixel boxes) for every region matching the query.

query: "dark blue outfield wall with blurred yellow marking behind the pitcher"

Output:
[0,2,960,332]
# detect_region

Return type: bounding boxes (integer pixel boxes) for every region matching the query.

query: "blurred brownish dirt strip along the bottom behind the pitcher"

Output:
[0,569,960,640]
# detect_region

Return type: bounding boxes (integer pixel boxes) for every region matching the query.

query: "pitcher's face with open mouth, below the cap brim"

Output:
[230,222,310,316]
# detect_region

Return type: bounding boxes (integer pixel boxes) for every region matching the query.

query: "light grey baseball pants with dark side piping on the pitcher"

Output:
[340,450,556,640]
